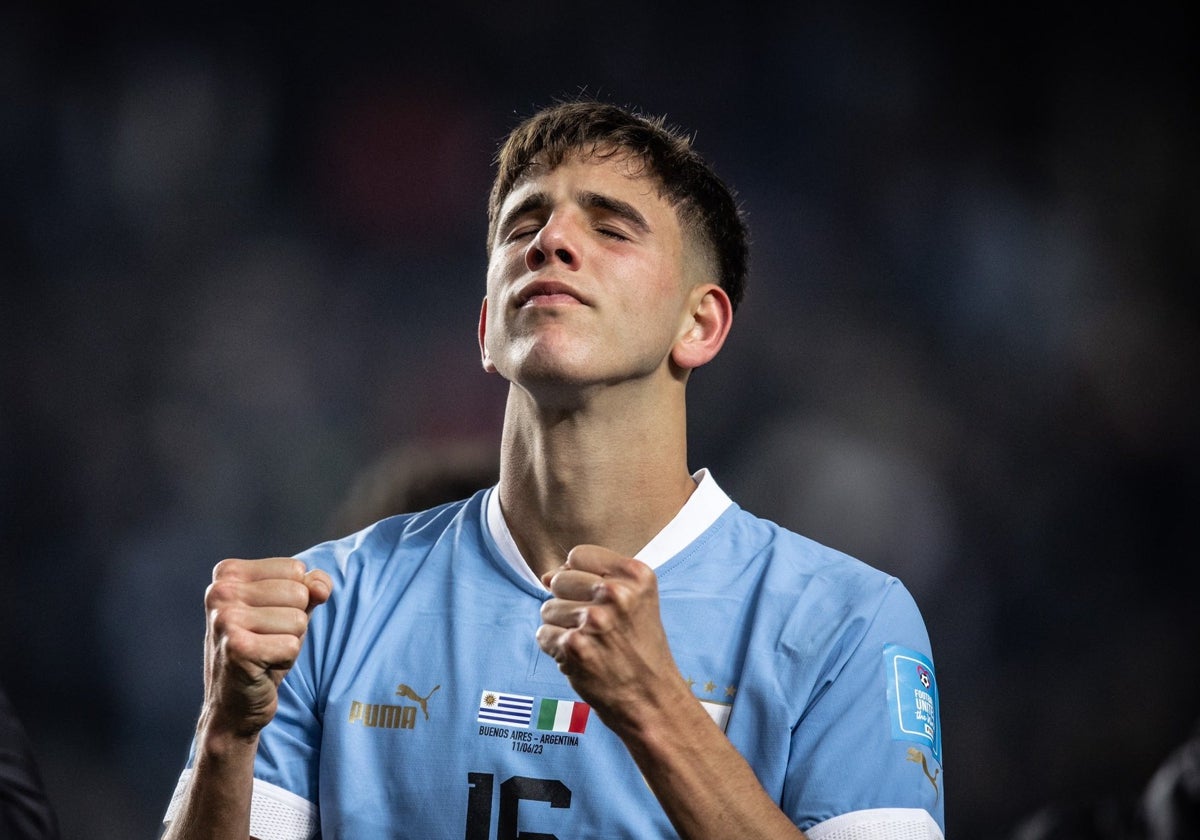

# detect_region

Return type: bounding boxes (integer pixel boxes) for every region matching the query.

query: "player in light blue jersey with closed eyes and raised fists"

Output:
[167,102,943,840]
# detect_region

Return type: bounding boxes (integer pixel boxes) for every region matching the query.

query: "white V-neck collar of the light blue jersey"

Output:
[487,469,733,589]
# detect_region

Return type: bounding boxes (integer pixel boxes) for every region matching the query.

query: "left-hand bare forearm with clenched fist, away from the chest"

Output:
[163,557,332,840]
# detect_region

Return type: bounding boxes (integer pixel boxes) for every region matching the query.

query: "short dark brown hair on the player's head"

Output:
[487,101,749,310]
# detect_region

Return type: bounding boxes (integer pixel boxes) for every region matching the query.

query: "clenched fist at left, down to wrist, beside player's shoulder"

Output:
[204,557,334,738]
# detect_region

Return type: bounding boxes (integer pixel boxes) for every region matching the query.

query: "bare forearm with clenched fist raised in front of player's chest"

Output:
[538,546,804,840]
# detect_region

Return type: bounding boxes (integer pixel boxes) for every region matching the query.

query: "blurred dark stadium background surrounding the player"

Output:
[0,0,1200,840]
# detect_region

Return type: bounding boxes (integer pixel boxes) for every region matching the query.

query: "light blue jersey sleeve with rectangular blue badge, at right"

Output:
[781,578,944,840]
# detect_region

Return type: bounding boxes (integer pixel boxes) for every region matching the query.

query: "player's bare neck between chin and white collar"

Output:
[499,385,695,576]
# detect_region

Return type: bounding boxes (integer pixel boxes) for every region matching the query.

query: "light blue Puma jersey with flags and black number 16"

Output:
[168,478,944,840]
